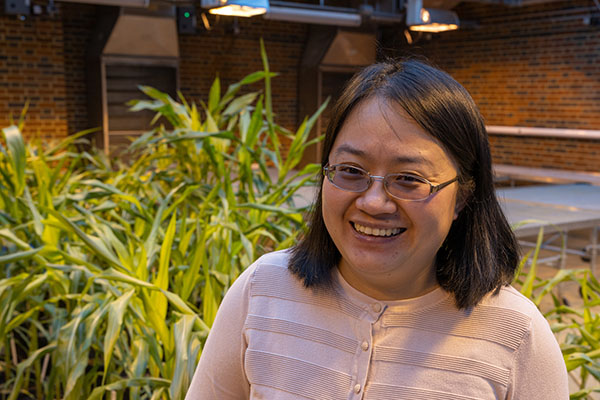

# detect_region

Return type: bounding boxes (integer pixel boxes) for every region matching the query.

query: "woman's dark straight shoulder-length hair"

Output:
[289,59,519,308]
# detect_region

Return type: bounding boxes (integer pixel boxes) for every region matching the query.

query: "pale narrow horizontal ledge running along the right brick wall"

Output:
[493,164,600,186]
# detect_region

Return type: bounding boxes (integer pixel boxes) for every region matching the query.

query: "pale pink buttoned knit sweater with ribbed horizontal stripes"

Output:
[186,251,569,400]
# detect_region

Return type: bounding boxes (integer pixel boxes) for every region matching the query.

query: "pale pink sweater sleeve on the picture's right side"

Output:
[507,312,569,400]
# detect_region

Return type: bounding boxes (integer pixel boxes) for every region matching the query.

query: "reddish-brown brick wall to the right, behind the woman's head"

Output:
[382,0,600,171]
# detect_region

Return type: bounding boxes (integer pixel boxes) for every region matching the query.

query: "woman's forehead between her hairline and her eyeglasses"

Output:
[329,97,454,170]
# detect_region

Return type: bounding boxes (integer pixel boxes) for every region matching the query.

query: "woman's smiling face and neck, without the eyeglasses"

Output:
[322,97,459,300]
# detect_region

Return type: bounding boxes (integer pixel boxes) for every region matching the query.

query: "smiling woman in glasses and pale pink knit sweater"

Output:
[187,60,569,400]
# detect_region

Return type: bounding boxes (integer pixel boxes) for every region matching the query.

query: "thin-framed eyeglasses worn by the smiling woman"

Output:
[323,164,458,201]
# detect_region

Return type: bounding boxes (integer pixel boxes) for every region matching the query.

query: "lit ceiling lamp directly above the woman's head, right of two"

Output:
[406,0,460,33]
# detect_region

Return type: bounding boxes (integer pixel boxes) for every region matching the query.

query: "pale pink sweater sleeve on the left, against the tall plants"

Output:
[185,266,255,400]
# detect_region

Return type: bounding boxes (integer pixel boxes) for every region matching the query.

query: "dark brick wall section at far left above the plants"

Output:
[0,3,68,138]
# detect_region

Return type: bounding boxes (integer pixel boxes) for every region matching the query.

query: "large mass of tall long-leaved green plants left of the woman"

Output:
[0,44,321,400]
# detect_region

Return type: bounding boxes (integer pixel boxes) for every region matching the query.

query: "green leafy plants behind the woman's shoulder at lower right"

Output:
[516,228,600,400]
